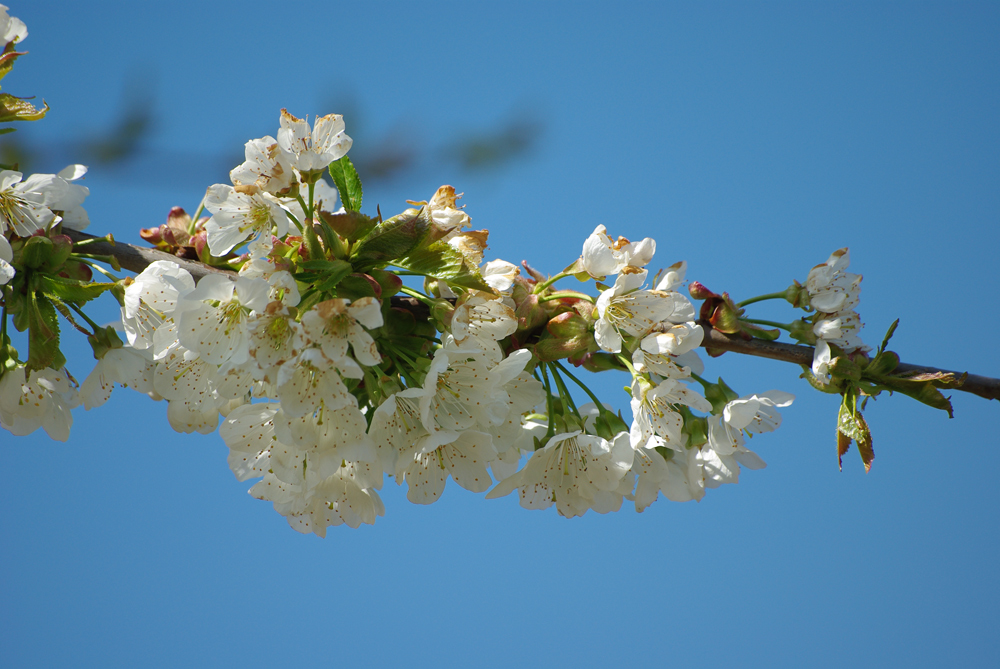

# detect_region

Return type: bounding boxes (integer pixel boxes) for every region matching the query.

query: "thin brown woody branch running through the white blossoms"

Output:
[63,230,1000,400]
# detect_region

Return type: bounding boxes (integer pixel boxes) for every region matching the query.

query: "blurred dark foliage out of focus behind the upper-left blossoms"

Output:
[0,72,545,188]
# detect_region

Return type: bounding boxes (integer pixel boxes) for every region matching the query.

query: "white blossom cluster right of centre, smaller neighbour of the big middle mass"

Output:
[488,225,793,516]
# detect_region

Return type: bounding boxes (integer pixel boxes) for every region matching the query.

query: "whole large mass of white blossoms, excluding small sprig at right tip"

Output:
[0,98,792,535]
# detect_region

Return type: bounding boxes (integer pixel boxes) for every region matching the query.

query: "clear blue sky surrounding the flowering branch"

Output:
[0,0,1000,667]
